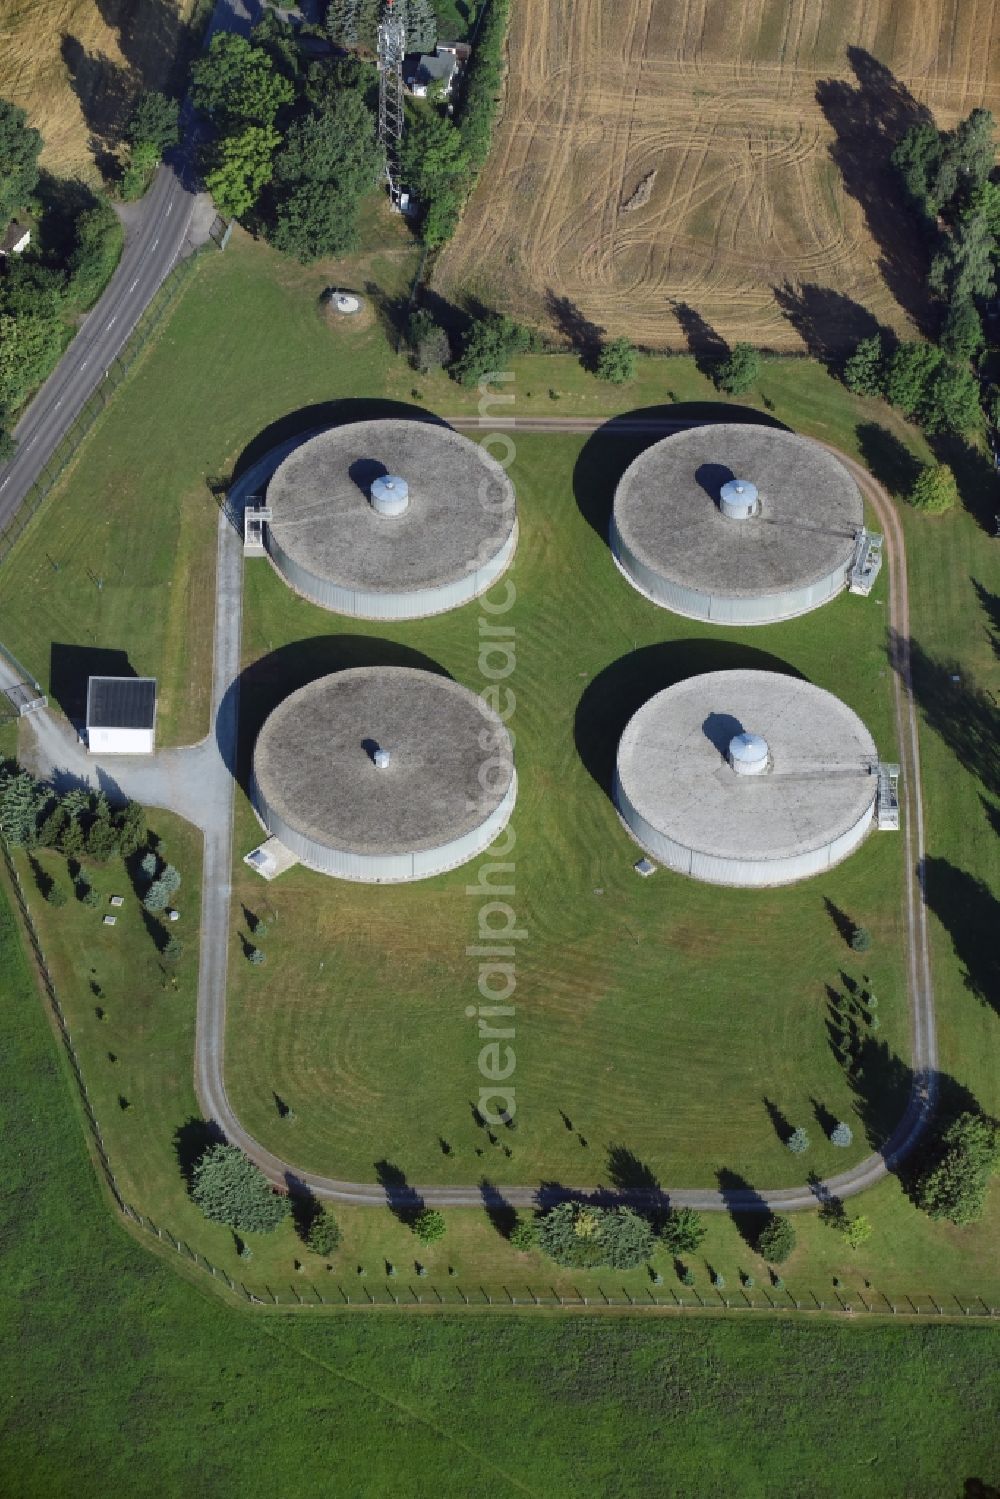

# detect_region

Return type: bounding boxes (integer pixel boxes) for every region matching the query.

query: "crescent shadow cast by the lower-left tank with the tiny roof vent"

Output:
[219,636,448,791]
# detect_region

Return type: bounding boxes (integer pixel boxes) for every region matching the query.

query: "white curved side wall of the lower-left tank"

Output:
[250,770,517,884]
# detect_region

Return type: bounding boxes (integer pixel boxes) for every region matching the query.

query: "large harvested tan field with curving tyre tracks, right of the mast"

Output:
[435,0,1000,349]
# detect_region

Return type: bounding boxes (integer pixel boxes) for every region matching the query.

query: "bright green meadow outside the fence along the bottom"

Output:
[0,875,997,1499]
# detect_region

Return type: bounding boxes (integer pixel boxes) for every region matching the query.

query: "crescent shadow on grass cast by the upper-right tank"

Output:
[573,400,789,540]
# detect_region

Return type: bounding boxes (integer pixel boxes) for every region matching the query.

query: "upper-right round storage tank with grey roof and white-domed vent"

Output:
[610,423,864,625]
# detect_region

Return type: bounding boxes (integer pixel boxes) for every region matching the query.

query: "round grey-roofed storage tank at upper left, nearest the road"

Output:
[264,418,517,619]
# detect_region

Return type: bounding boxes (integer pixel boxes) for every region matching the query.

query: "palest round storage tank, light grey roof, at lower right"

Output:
[613,672,879,886]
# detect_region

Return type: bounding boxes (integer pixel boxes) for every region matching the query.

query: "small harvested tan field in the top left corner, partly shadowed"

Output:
[0,0,196,177]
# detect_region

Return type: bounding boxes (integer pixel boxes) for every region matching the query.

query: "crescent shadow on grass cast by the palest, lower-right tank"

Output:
[573,640,799,794]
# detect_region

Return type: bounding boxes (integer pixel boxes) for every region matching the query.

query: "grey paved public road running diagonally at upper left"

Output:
[0,0,261,531]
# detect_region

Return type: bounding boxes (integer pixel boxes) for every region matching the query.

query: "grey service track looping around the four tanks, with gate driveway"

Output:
[13,417,937,1211]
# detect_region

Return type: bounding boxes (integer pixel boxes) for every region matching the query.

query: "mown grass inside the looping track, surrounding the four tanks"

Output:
[226,436,907,1186]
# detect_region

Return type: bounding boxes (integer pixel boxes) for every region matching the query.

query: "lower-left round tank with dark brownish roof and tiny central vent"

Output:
[250,667,517,884]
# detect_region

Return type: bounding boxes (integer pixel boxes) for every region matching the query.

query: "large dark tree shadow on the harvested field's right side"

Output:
[816,46,933,333]
